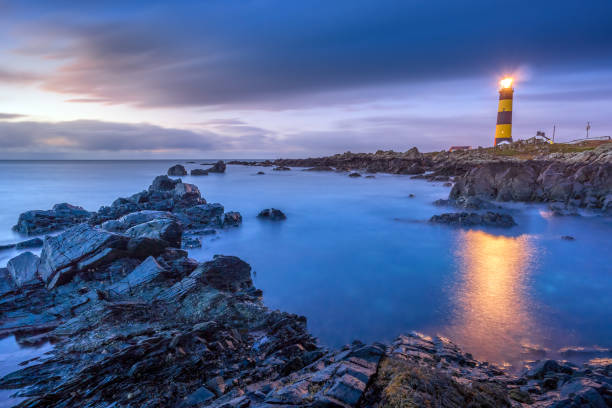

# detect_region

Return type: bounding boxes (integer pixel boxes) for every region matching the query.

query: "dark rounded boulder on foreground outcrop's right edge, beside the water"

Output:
[201,255,253,292]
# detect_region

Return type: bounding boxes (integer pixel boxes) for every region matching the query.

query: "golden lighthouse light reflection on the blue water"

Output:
[449,230,538,361]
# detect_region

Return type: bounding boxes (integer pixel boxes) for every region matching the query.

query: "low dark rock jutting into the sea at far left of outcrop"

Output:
[13,203,92,235]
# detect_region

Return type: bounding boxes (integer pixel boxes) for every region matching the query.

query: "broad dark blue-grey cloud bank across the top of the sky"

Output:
[8,0,612,107]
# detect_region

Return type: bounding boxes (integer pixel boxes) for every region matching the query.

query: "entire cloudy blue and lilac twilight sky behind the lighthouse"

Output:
[0,0,612,159]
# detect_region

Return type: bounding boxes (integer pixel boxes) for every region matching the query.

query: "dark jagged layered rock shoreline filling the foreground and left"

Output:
[0,167,612,407]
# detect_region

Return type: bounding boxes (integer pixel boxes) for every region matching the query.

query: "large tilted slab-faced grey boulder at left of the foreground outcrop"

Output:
[39,224,128,288]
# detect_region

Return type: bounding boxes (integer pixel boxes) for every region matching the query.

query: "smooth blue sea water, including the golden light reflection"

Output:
[0,160,612,373]
